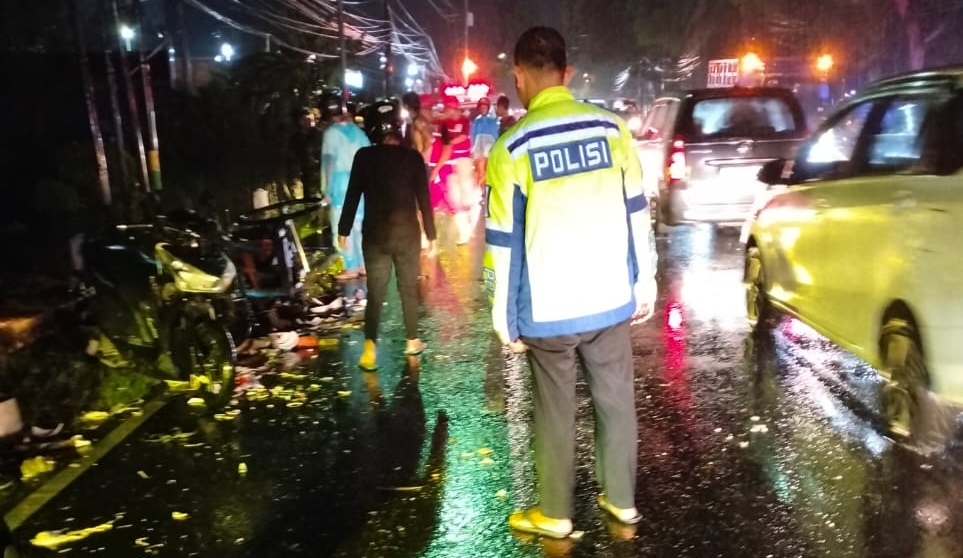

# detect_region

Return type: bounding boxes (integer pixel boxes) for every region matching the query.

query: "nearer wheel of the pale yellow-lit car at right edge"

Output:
[879,318,929,441]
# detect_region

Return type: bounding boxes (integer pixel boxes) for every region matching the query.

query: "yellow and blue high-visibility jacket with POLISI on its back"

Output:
[484,87,656,343]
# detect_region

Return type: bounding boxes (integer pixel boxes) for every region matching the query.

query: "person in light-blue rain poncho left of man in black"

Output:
[321,93,371,280]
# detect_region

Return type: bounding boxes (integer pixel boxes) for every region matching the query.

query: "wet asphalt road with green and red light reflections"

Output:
[7,223,963,558]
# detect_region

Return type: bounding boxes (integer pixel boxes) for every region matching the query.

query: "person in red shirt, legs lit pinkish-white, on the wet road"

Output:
[431,96,476,245]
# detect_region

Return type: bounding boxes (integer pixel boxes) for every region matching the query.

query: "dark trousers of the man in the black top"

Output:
[361,241,421,341]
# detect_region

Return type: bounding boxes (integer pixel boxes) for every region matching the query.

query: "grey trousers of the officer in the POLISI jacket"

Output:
[522,321,638,518]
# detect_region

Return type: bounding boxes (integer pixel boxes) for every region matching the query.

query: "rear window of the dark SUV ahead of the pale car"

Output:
[688,96,803,142]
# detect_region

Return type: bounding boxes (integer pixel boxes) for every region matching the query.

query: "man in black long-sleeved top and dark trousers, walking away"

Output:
[338,125,436,370]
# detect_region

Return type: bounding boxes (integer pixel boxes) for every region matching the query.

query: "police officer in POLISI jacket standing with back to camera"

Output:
[485,27,656,538]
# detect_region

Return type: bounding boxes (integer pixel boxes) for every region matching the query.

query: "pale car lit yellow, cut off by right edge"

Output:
[742,66,963,442]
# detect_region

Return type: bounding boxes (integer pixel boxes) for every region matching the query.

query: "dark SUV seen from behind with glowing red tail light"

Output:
[637,87,806,230]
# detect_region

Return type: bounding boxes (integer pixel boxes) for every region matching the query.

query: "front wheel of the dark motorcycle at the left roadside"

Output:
[171,320,237,408]
